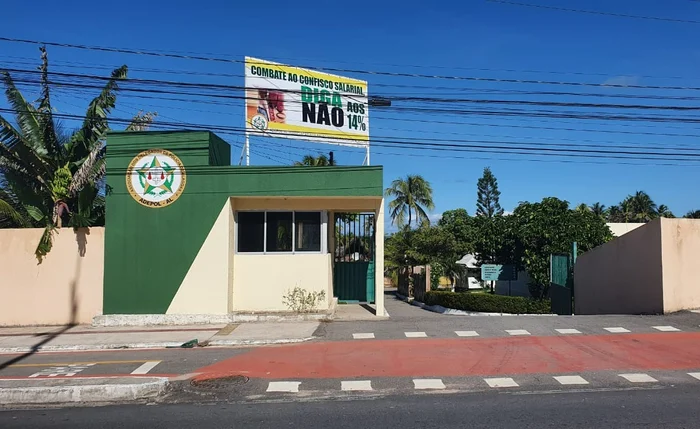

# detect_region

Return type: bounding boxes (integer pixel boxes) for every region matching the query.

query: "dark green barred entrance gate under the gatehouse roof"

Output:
[333,213,375,303]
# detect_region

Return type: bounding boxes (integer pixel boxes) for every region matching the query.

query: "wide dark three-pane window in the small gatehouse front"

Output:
[236,211,325,253]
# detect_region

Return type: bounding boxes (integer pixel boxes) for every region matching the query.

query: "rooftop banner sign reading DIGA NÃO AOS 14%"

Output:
[245,57,369,147]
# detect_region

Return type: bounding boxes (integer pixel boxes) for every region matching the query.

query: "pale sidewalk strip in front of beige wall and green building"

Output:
[0,322,319,353]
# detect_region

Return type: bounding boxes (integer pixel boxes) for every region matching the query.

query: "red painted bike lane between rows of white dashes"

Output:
[196,332,700,379]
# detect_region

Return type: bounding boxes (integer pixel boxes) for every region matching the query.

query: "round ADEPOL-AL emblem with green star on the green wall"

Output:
[126,149,187,208]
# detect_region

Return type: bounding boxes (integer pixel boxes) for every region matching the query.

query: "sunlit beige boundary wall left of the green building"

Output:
[0,228,104,326]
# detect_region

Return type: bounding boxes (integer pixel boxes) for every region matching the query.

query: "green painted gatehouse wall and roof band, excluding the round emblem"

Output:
[103,131,383,314]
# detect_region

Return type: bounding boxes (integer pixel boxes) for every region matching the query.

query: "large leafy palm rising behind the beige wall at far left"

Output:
[0,47,153,260]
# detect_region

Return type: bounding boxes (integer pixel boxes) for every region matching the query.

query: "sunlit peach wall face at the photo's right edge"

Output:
[661,219,700,313]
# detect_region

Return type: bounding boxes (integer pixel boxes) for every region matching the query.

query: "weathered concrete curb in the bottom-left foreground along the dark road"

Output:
[0,378,169,405]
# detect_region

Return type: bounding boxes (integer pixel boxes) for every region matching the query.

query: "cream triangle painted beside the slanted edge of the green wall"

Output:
[166,200,233,314]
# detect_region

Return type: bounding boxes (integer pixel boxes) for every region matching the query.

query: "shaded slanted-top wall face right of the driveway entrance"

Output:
[574,220,663,314]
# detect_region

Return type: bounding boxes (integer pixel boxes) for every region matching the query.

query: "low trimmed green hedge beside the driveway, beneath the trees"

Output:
[425,291,551,314]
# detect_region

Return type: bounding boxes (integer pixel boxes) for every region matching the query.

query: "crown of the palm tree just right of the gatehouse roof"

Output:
[385,175,435,228]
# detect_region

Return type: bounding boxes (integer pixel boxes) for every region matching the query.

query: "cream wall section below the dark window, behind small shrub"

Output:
[233,253,333,311]
